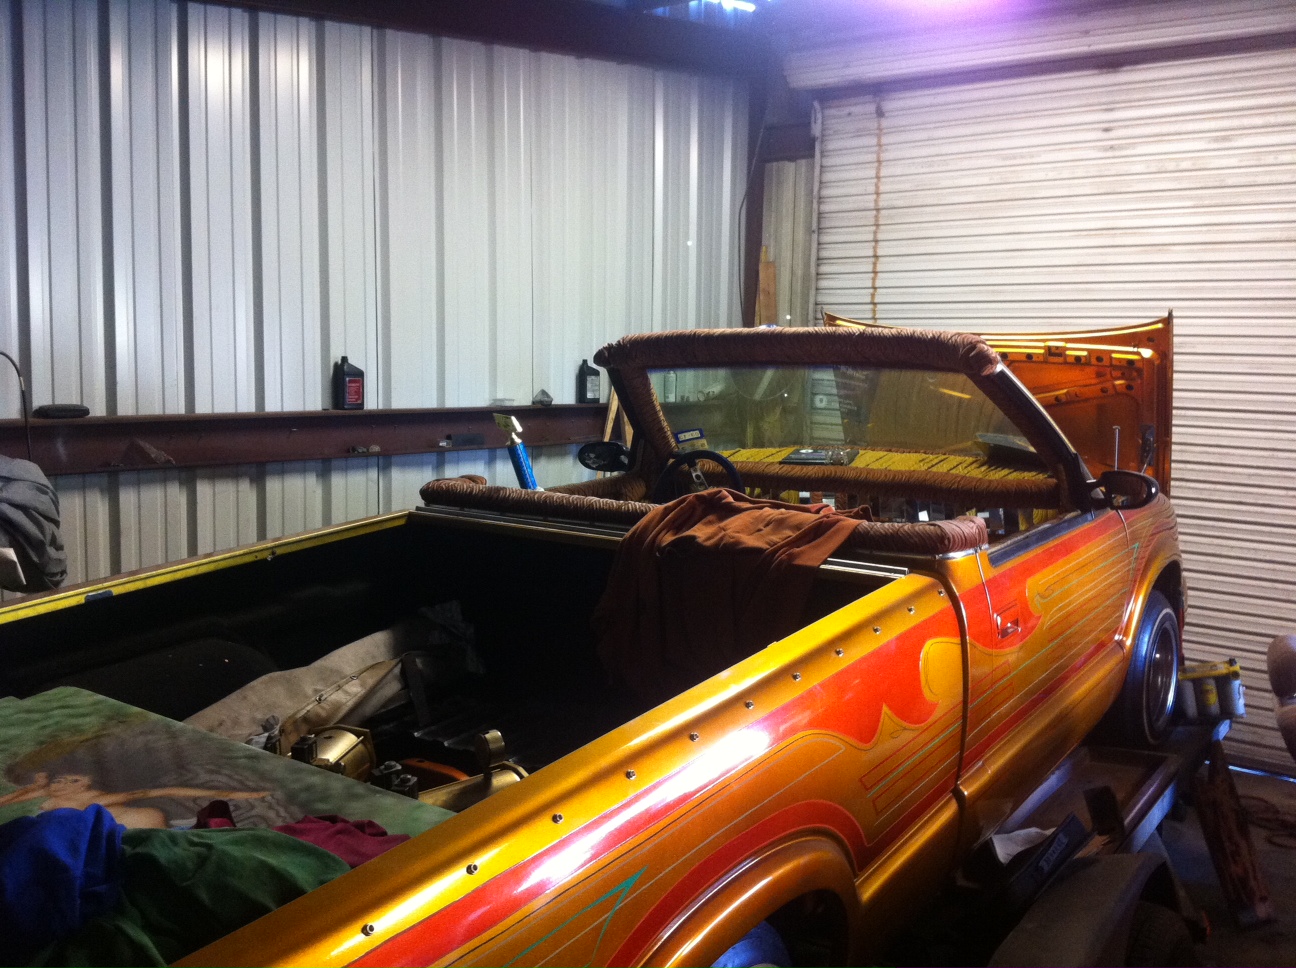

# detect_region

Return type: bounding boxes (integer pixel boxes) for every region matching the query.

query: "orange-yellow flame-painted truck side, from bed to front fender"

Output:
[54,492,1175,968]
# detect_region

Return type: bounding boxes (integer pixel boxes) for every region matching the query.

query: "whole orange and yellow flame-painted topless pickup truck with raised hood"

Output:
[0,317,1185,968]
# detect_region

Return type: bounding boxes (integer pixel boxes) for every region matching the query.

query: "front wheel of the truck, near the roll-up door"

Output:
[1103,590,1181,748]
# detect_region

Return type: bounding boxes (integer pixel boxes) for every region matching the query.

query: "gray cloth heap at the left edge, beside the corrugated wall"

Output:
[0,456,67,592]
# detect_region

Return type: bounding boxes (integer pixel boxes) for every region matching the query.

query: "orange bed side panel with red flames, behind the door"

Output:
[177,575,963,968]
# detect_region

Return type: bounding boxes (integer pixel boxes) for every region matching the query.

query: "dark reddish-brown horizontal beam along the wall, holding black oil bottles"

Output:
[0,404,607,476]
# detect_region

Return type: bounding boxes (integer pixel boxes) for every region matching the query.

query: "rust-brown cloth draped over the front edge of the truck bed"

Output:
[594,489,858,702]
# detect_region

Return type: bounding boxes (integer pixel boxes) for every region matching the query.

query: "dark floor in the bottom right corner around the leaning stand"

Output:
[1161,771,1296,968]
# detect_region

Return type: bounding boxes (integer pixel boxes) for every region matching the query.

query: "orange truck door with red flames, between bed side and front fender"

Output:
[960,511,1133,837]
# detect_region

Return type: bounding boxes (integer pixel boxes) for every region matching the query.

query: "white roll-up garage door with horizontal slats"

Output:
[798,4,1296,770]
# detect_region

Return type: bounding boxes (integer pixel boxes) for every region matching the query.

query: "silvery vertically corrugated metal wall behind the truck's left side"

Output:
[0,0,746,590]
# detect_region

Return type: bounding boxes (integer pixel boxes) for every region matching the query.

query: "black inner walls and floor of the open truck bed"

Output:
[4,512,885,772]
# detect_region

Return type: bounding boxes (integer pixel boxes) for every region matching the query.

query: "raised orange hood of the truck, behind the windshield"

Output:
[824,312,1174,492]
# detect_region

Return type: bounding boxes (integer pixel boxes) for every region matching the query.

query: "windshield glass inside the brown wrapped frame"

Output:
[649,367,1037,464]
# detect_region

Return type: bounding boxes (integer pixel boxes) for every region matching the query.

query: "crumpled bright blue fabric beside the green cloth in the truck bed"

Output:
[0,803,124,956]
